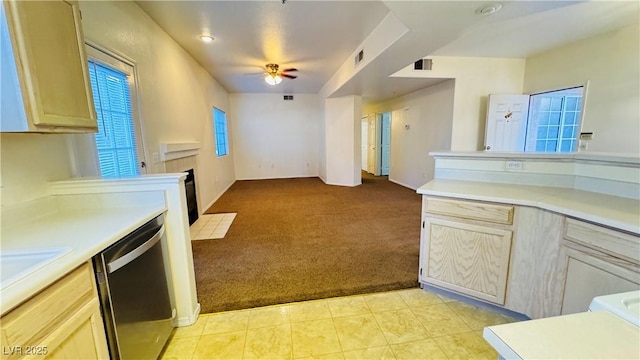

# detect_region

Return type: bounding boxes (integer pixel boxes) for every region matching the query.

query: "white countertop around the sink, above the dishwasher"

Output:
[0,204,166,314]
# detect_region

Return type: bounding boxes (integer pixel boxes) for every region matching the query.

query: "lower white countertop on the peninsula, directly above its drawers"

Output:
[417,179,640,234]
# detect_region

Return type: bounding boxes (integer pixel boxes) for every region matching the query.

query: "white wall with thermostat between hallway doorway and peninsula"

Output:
[367,80,456,189]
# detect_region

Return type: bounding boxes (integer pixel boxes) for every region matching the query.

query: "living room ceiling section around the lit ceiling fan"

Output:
[138,0,389,93]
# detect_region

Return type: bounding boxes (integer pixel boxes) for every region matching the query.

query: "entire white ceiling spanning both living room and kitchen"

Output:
[137,0,640,101]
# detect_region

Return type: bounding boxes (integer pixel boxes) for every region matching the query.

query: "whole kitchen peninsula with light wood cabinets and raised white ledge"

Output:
[418,152,640,318]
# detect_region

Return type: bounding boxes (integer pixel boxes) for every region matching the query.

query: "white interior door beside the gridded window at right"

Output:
[484,94,529,152]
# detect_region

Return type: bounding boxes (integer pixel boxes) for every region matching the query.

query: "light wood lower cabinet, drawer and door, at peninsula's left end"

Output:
[420,197,513,305]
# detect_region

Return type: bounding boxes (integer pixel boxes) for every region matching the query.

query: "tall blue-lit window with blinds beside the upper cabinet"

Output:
[89,61,139,177]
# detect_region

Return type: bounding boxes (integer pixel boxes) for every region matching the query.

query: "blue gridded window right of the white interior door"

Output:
[526,87,583,152]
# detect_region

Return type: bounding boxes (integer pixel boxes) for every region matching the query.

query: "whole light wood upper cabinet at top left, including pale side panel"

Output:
[0,0,97,132]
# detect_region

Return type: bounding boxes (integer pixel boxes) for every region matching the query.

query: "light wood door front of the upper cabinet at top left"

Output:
[5,0,97,131]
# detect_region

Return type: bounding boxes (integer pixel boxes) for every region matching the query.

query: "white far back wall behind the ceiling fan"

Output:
[230,94,323,179]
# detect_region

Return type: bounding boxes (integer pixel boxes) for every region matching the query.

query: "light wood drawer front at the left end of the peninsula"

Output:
[423,197,513,225]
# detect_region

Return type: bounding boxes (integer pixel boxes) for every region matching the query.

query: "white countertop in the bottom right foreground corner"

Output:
[483,311,640,359]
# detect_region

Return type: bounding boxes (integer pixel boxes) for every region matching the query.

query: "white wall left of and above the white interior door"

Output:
[394,56,525,151]
